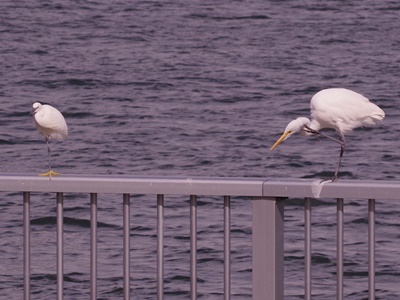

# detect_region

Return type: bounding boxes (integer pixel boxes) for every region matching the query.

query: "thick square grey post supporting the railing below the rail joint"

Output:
[253,197,284,300]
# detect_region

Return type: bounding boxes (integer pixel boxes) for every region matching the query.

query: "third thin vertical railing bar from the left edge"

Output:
[90,193,97,300]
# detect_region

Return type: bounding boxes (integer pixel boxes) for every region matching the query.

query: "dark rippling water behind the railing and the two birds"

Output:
[0,0,400,300]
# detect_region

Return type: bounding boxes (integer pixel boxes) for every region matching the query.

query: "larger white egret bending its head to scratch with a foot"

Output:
[270,88,385,181]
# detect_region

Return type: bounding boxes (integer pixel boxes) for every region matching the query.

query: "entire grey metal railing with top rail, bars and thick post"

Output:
[0,175,400,300]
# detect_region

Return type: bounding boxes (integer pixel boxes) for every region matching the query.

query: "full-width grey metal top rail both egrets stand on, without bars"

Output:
[0,174,400,200]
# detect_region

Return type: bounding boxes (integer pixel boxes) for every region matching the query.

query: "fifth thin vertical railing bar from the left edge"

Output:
[157,195,164,300]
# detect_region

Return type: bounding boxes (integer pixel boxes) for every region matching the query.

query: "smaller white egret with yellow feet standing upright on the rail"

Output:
[32,102,68,177]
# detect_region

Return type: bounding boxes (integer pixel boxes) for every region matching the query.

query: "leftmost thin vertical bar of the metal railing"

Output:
[23,192,31,300]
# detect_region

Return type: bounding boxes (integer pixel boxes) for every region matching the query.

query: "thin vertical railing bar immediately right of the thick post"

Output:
[304,198,312,300]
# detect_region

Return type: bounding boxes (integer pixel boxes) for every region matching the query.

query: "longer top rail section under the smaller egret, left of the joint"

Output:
[0,175,264,196]
